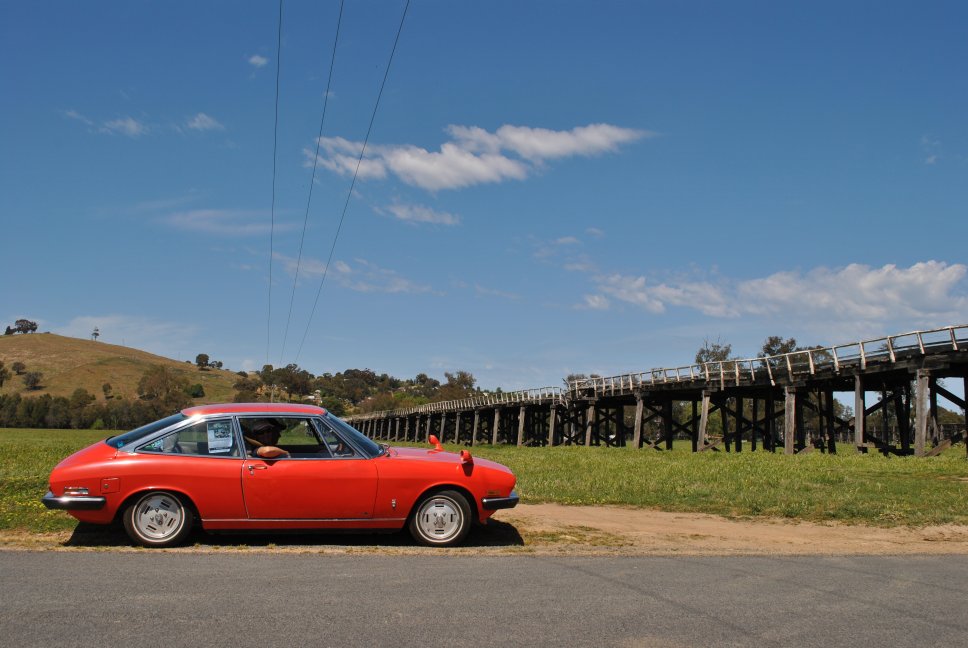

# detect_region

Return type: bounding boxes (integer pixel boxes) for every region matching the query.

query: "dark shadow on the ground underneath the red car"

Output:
[63,519,524,548]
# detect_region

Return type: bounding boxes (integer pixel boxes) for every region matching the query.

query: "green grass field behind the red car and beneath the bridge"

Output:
[0,429,968,532]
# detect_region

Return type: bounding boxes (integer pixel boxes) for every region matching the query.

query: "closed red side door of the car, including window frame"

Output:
[240,417,377,520]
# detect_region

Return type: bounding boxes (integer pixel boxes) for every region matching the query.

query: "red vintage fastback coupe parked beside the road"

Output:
[43,403,518,547]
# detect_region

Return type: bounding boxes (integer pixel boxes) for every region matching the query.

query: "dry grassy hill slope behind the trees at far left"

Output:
[0,333,239,403]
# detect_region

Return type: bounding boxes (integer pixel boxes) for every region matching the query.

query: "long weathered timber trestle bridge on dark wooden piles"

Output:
[346,325,968,456]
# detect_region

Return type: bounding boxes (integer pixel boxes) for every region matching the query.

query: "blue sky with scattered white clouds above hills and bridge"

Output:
[0,0,968,389]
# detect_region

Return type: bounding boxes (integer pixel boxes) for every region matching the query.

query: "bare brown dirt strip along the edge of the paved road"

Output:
[0,504,968,556]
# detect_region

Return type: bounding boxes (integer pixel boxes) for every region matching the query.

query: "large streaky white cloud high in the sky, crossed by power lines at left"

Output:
[304,124,653,191]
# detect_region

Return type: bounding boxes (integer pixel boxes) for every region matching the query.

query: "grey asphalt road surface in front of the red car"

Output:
[0,551,968,648]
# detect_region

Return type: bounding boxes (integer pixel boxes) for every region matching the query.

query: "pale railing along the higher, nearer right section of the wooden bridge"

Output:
[567,324,968,398]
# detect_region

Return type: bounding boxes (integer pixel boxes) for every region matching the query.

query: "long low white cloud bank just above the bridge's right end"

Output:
[585,261,968,326]
